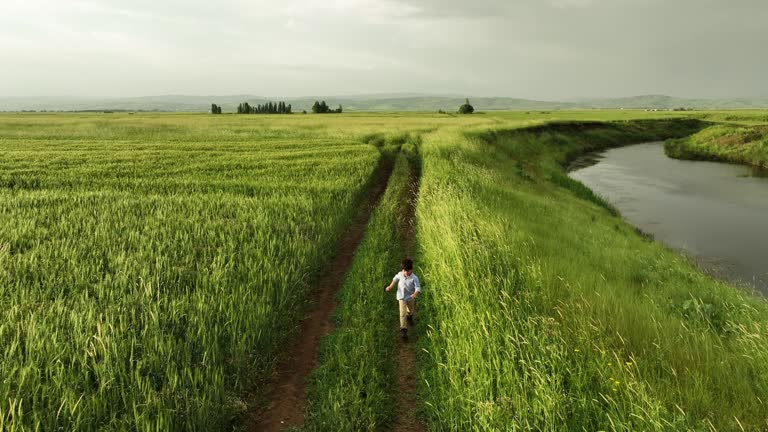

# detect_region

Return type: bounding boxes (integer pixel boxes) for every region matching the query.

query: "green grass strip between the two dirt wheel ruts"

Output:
[306,144,410,431]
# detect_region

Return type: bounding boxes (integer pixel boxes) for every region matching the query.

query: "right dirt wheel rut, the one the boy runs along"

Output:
[394,163,425,432]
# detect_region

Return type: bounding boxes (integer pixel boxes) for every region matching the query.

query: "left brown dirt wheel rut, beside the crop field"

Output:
[248,158,393,432]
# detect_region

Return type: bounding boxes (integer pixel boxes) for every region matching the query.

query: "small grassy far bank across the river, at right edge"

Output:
[664,124,768,169]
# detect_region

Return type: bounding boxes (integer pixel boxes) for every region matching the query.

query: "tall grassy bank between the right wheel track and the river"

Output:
[417,121,768,431]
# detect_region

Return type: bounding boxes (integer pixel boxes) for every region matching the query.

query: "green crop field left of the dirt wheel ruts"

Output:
[0,116,379,431]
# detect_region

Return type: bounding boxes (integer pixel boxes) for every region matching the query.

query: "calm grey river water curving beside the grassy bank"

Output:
[570,143,768,294]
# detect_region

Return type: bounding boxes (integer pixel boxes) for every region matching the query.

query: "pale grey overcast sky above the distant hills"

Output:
[0,0,768,100]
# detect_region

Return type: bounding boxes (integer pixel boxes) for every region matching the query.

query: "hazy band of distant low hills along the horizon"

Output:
[0,94,768,112]
